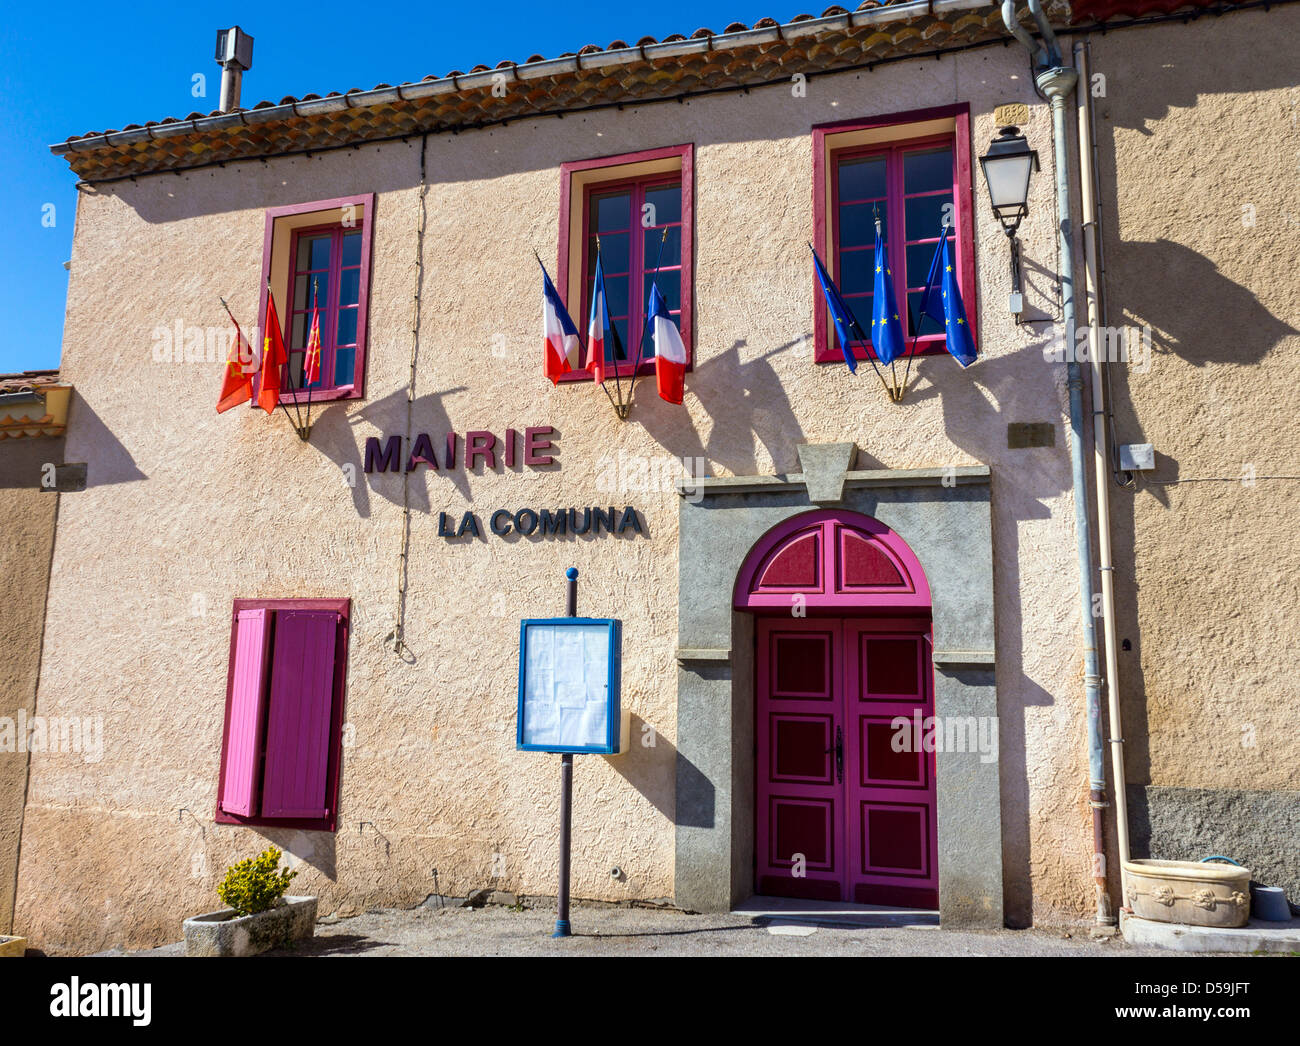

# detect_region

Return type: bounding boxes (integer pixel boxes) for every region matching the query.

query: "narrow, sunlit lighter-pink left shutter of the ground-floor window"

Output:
[218,609,270,817]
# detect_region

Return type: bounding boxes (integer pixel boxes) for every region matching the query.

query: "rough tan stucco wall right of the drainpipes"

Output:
[1092,6,1300,800]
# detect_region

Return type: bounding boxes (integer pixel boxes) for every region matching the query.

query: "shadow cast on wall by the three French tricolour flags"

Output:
[634,338,807,476]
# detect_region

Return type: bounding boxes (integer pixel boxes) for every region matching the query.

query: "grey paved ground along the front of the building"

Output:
[108,902,1216,956]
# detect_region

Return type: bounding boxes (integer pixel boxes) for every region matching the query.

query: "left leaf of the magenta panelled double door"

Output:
[755,620,844,900]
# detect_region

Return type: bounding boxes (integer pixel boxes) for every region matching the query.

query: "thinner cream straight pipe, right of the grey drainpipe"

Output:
[1074,40,1128,883]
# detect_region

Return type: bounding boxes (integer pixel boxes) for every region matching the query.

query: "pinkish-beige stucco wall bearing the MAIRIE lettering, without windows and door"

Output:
[18,48,1091,950]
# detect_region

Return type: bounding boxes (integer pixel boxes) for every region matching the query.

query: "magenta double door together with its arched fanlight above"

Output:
[733,511,939,908]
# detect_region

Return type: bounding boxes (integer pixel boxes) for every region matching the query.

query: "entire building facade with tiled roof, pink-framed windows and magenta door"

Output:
[7,0,1300,951]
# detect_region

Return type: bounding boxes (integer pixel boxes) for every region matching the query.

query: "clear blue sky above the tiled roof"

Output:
[0,0,785,372]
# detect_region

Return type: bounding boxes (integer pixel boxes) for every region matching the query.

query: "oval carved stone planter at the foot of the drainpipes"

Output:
[1125,860,1251,928]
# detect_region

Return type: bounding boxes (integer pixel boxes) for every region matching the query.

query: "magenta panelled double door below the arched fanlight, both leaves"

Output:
[755,617,939,908]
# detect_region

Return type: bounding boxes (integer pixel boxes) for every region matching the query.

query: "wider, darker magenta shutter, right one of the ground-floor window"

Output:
[261,611,339,817]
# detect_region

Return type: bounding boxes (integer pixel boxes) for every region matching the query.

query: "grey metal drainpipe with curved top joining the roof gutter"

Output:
[1002,0,1115,925]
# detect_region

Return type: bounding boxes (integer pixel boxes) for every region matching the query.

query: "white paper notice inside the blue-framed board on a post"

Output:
[523,625,610,748]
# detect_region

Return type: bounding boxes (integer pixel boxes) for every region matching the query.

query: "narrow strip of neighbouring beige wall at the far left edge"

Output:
[0,438,64,933]
